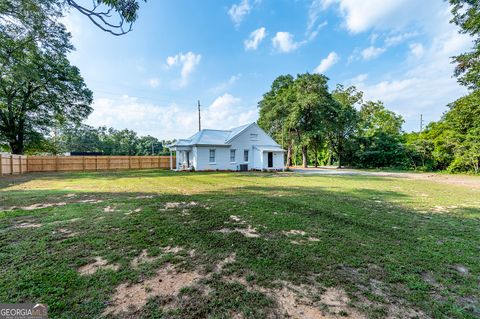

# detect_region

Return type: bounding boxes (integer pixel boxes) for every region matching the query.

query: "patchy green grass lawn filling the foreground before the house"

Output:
[0,170,480,318]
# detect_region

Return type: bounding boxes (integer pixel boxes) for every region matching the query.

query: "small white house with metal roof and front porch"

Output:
[168,123,285,171]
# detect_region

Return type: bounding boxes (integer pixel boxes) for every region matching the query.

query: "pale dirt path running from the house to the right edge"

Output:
[292,167,480,189]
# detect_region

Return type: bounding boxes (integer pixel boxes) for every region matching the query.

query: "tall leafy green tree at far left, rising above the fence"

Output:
[0,1,92,154]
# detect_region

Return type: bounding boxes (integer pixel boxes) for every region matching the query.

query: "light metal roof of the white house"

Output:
[168,122,255,147]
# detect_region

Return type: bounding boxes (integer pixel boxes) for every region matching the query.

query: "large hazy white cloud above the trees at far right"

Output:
[353,4,472,130]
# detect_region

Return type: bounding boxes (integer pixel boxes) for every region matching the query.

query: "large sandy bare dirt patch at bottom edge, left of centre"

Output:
[103,264,201,316]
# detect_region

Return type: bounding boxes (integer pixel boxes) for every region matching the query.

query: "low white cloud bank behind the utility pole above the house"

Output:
[86,94,258,139]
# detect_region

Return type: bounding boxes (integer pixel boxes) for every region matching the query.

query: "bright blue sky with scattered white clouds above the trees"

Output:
[63,0,472,139]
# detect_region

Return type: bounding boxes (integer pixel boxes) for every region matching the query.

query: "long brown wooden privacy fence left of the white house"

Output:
[0,154,176,175]
